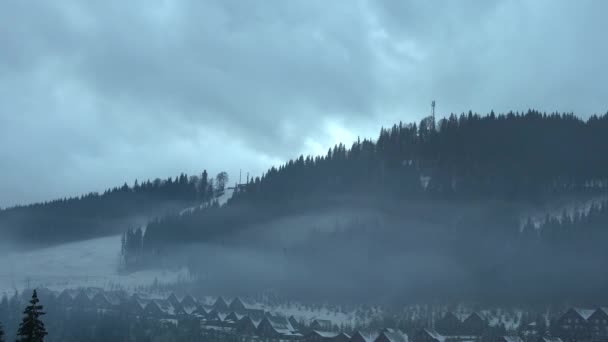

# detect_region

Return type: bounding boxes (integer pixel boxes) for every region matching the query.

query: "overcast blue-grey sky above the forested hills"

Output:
[0,0,608,207]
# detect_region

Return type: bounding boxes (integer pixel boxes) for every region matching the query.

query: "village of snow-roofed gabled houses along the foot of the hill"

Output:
[39,289,608,342]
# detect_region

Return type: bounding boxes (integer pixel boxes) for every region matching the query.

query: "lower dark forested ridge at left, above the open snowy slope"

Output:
[0,171,223,245]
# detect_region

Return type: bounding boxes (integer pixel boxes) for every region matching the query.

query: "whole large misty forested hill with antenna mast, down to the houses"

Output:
[120,111,608,301]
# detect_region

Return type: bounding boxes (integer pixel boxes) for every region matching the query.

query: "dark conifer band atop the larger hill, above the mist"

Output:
[140,111,608,246]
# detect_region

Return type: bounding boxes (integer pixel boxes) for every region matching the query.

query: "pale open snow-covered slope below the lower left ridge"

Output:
[0,235,188,295]
